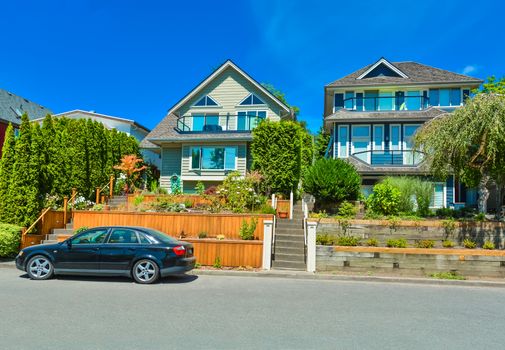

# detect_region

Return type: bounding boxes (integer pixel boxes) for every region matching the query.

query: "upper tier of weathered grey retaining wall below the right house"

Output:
[317,219,505,249]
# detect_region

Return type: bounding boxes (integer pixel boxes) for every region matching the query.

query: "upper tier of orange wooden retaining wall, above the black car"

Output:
[73,211,273,240]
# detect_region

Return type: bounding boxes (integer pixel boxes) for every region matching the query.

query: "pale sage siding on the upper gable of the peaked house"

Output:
[178,68,281,130]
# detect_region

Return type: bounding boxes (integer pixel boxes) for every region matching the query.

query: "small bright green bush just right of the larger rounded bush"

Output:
[366,180,401,215]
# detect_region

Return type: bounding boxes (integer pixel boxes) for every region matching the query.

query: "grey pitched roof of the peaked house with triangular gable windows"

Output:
[140,60,290,148]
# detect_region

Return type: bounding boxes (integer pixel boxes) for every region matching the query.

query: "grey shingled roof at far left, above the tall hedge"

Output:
[0,89,52,125]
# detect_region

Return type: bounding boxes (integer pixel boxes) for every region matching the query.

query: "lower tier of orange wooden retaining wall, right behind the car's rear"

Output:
[184,239,263,267]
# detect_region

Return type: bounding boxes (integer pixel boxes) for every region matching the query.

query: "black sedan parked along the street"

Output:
[16,226,196,284]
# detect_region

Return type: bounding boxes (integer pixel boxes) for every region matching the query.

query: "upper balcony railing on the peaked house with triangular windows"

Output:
[176,114,265,133]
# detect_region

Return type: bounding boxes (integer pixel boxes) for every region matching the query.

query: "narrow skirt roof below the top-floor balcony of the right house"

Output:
[324,107,447,123]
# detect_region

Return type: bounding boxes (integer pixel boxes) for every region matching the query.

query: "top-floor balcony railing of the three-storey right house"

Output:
[343,96,430,111]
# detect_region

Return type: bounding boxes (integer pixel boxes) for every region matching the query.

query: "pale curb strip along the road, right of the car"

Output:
[188,269,505,288]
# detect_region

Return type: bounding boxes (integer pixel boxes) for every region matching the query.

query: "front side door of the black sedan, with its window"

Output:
[54,228,108,273]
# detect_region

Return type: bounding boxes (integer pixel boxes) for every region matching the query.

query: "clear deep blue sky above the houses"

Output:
[0,0,505,131]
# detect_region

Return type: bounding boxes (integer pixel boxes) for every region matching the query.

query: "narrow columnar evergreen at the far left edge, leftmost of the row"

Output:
[0,124,16,222]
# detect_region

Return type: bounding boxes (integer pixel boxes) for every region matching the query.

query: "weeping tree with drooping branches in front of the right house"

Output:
[415,93,505,213]
